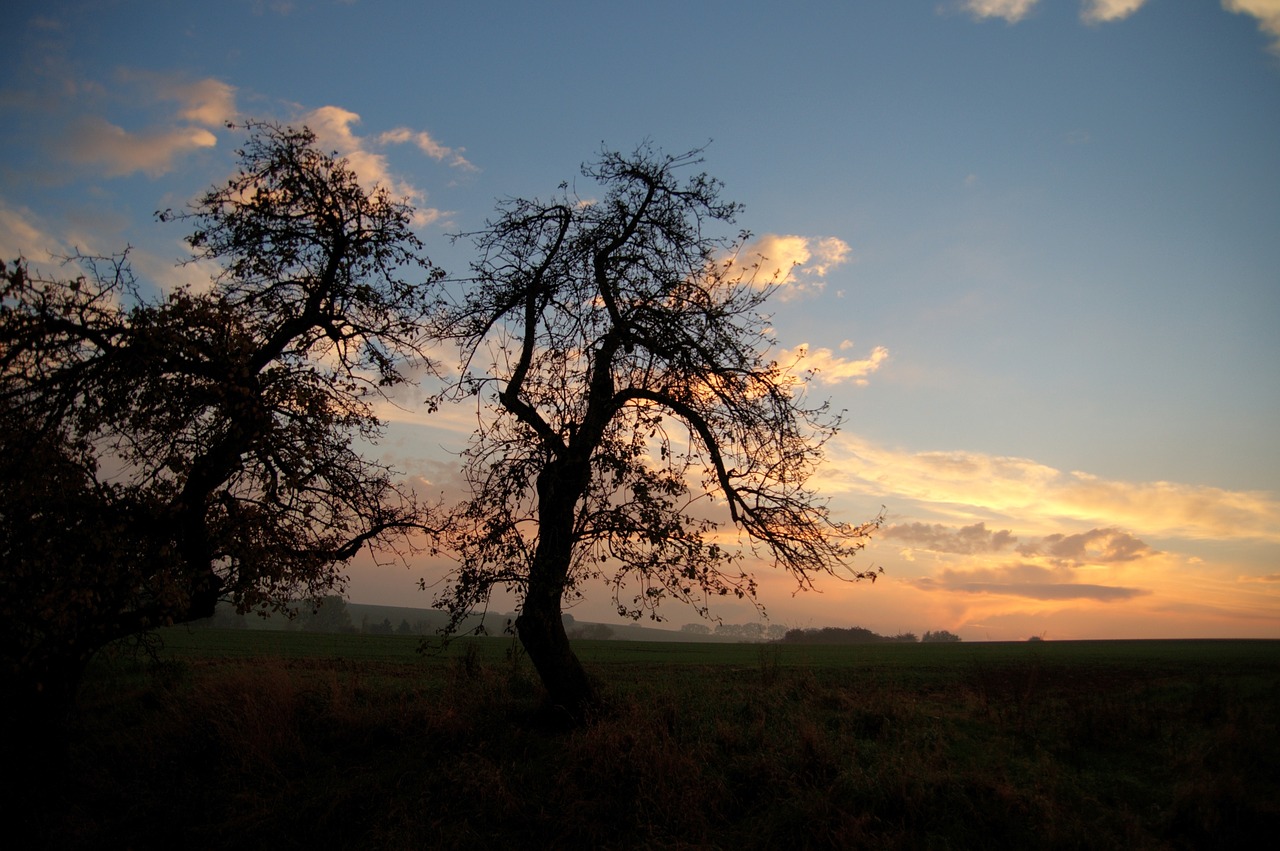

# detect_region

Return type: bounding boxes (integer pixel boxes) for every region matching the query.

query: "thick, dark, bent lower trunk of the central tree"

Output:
[516,459,599,724]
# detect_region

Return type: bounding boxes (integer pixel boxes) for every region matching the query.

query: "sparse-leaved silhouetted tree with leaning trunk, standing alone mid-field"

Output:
[436,146,878,719]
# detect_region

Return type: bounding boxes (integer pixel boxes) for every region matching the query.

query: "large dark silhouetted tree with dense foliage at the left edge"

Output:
[0,124,440,737]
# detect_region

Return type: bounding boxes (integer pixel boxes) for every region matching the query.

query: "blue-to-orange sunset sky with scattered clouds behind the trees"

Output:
[0,0,1280,641]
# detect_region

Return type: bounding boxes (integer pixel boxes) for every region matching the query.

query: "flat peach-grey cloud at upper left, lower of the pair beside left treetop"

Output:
[63,116,218,178]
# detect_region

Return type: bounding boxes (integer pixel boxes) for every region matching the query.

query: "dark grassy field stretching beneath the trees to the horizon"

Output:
[26,630,1280,850]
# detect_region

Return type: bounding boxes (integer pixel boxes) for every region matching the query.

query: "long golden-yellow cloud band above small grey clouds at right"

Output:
[820,434,1280,543]
